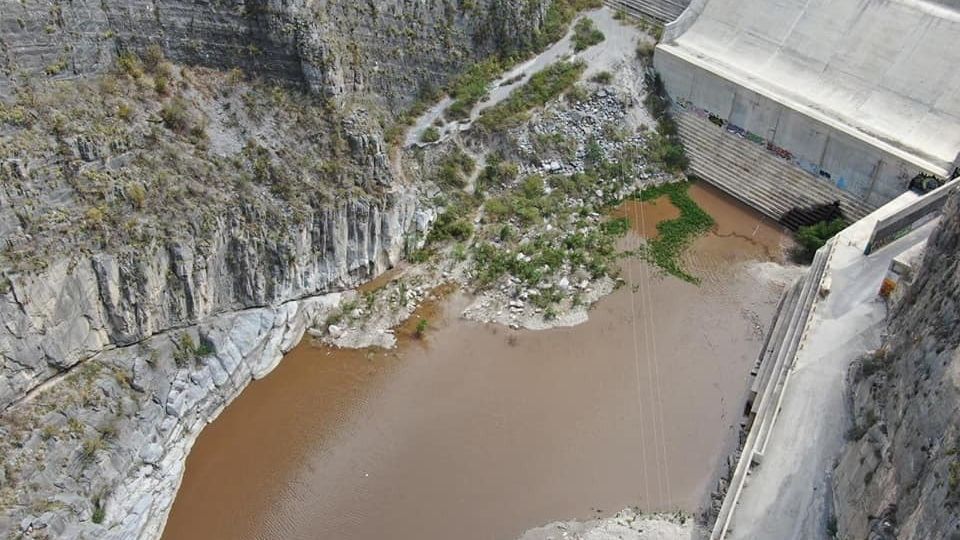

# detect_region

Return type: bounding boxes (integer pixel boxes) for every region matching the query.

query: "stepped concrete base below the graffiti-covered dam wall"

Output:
[676,112,876,229]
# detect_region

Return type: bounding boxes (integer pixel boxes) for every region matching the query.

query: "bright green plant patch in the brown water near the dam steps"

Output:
[639,182,714,283]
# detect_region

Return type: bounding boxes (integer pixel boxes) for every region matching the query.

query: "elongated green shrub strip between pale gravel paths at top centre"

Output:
[478,61,587,131]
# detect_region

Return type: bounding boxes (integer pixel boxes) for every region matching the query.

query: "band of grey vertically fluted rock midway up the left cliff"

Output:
[0,190,433,407]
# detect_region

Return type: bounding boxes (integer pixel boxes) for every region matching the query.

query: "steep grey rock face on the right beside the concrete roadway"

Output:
[834,188,960,539]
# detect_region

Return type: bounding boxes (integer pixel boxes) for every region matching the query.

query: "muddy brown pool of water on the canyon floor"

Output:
[164,185,784,540]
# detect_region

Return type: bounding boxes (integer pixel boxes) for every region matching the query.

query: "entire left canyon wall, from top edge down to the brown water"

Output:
[0,0,550,538]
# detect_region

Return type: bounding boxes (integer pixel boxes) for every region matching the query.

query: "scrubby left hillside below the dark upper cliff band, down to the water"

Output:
[0,59,434,538]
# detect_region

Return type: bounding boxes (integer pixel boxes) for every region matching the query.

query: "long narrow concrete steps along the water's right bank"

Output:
[710,240,833,540]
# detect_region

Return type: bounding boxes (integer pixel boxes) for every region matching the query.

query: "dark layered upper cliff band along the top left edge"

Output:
[0,0,549,106]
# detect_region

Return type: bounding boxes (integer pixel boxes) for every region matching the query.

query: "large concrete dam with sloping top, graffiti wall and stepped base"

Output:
[654,0,960,226]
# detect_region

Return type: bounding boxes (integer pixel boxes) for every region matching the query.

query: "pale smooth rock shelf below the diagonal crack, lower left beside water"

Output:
[0,293,340,539]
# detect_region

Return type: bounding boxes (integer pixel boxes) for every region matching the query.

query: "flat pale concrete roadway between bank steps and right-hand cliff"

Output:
[727,194,935,540]
